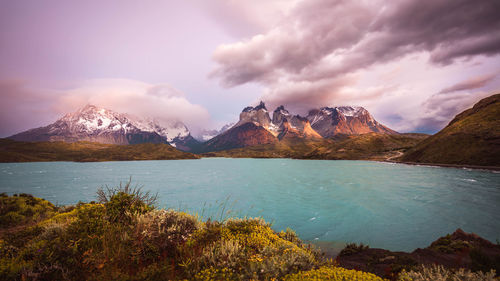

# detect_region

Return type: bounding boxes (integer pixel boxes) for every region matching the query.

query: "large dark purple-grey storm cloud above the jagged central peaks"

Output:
[211,0,500,132]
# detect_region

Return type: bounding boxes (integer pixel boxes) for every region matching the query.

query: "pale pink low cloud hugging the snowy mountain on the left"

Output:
[0,79,210,136]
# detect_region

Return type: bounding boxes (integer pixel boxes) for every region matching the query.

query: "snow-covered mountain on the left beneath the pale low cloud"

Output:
[9,105,197,150]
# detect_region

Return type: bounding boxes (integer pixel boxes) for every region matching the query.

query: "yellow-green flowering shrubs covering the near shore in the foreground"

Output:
[0,182,498,281]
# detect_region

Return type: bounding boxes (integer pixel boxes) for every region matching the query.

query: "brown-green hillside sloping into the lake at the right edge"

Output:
[398,94,500,167]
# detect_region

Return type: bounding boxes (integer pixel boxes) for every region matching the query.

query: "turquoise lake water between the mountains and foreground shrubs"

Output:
[0,158,500,251]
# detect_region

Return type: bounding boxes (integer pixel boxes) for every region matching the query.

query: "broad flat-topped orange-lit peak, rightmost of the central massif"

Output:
[307,106,397,138]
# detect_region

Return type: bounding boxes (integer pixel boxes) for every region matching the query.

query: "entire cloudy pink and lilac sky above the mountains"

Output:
[0,0,500,137]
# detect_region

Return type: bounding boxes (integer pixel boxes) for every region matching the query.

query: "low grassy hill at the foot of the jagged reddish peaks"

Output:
[202,133,427,160]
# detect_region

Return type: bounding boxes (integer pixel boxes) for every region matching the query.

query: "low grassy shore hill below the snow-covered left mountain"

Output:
[0,139,199,162]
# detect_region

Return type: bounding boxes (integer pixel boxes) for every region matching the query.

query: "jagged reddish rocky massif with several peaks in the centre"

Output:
[197,101,398,152]
